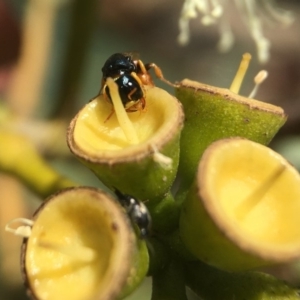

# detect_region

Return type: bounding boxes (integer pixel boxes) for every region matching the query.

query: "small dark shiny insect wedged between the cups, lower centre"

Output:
[115,189,151,239]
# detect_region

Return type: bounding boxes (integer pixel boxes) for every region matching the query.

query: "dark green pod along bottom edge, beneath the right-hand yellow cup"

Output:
[186,262,300,300]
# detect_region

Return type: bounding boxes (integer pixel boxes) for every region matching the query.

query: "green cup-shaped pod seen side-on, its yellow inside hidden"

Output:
[176,79,286,187]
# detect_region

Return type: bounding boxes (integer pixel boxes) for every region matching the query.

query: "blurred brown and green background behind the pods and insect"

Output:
[0,0,300,300]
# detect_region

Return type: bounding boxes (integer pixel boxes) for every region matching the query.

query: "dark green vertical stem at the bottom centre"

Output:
[151,258,187,300]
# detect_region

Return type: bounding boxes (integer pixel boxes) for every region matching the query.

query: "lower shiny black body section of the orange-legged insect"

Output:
[105,74,144,111]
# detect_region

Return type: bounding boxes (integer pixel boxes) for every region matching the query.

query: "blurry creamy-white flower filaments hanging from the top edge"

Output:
[178,0,294,63]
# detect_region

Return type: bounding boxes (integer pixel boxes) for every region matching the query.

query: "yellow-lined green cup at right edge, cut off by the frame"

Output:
[180,138,300,271]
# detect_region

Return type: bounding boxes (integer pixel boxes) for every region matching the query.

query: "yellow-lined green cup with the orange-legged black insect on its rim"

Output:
[67,86,184,201]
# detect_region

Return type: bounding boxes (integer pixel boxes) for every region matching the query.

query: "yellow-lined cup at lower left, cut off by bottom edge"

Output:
[21,187,149,300]
